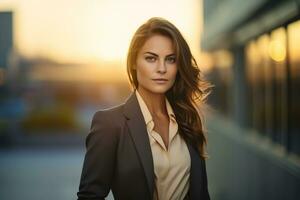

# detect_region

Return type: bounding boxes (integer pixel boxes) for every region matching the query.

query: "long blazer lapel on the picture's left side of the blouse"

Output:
[124,92,155,199]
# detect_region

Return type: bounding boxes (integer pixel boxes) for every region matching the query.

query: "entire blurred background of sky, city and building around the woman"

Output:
[0,0,300,200]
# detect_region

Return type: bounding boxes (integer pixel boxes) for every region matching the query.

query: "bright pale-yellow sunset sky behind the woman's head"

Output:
[0,0,202,62]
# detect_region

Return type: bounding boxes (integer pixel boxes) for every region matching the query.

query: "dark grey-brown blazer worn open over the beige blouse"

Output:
[77,92,210,200]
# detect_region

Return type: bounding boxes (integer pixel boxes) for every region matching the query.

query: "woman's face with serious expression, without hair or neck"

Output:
[136,35,177,94]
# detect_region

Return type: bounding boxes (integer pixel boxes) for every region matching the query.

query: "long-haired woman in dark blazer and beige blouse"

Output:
[77,18,210,200]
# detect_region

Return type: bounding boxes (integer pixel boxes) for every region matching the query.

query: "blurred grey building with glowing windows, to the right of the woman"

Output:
[201,0,300,200]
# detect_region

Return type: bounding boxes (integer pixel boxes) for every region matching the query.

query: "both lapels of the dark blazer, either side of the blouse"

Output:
[124,92,204,199]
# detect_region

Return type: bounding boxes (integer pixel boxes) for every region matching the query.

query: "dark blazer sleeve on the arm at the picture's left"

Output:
[77,111,117,200]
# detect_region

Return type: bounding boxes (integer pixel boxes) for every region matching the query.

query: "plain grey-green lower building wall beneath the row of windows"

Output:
[207,115,300,200]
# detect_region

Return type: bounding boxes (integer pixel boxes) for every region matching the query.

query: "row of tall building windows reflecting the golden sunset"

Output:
[245,20,300,154]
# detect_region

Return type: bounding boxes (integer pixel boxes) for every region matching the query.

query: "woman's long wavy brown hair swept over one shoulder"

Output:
[127,17,212,158]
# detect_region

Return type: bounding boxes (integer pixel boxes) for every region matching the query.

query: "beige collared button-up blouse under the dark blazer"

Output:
[135,90,191,200]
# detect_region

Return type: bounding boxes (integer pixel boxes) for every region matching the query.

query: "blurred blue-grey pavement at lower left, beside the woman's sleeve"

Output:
[0,148,113,200]
